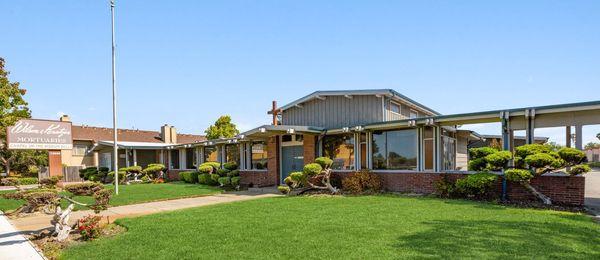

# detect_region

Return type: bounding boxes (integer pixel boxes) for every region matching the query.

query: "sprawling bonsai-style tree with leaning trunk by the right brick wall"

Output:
[469,144,591,204]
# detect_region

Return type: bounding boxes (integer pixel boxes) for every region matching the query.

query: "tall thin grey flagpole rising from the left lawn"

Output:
[110,0,119,195]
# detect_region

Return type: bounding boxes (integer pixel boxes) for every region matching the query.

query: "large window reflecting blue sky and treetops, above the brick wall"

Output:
[372,129,418,170]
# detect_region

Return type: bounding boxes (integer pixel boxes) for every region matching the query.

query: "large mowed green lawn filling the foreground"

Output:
[61,195,600,259]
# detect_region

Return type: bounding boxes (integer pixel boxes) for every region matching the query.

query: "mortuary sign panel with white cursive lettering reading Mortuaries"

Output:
[6,119,73,150]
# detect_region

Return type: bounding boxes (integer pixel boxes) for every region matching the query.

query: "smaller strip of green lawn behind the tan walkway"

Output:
[0,182,221,211]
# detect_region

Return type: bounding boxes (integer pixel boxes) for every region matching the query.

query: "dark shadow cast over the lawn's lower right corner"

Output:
[393,218,600,259]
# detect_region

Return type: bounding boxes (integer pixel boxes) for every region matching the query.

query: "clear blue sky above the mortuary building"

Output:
[0,0,600,143]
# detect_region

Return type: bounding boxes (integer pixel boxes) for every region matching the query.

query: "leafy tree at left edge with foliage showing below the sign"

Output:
[0,58,48,174]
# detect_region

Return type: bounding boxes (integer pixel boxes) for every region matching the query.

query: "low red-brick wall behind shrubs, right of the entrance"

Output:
[333,172,585,206]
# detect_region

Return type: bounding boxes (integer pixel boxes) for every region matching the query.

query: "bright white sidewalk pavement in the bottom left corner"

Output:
[0,211,44,260]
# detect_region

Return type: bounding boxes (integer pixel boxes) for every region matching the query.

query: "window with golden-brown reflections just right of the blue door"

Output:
[323,134,354,170]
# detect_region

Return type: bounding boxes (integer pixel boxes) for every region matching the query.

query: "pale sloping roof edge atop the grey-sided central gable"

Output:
[279,89,441,115]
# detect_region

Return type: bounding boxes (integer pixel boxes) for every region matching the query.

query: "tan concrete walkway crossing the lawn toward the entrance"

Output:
[11,192,279,234]
